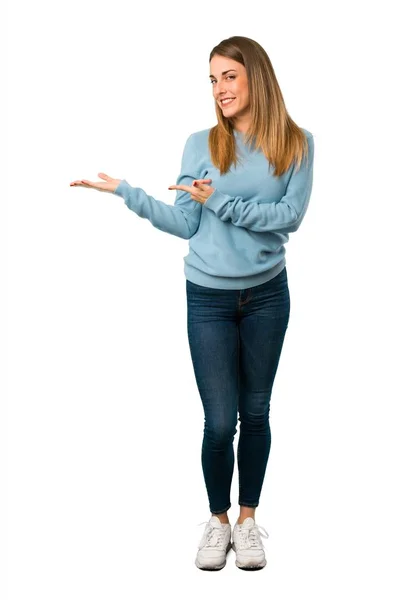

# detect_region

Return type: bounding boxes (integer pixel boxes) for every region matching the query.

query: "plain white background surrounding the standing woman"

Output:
[4,0,400,600]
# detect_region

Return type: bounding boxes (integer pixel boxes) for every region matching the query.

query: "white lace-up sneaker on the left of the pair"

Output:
[195,516,232,571]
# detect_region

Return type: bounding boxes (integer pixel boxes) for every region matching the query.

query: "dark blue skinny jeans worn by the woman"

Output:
[186,266,290,514]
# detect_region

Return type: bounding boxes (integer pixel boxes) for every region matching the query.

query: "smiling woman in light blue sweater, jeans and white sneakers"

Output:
[71,36,314,570]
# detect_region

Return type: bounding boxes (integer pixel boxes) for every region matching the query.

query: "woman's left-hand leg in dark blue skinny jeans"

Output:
[187,280,238,522]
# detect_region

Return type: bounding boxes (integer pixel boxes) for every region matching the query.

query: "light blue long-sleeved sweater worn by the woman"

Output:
[114,129,314,290]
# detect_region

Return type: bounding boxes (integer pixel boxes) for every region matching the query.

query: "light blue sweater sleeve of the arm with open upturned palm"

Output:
[114,134,202,239]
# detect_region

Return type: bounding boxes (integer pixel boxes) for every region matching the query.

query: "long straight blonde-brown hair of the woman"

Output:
[208,36,308,177]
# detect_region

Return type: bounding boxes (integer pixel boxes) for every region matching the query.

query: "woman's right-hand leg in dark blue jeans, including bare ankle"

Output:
[237,268,290,522]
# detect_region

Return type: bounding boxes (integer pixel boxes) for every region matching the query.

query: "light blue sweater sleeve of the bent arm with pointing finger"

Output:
[203,134,314,233]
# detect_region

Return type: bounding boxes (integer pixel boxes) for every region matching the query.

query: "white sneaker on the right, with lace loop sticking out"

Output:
[232,517,269,571]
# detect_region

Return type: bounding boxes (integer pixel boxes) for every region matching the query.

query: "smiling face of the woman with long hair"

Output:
[210,55,250,122]
